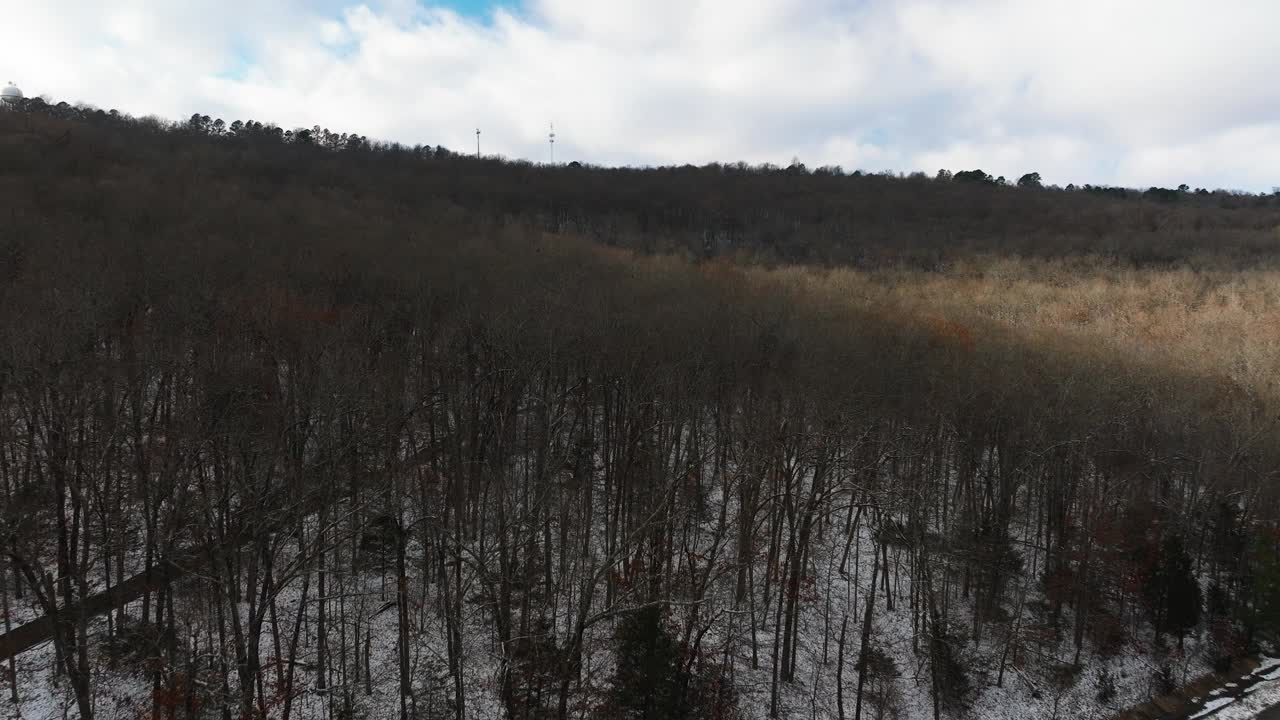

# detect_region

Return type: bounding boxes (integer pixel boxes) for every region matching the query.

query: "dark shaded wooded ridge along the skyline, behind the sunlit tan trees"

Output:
[10,100,1280,270]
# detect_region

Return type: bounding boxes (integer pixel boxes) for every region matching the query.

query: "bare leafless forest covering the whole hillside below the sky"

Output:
[0,101,1280,720]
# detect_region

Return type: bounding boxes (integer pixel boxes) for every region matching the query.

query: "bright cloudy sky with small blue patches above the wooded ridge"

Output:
[0,0,1280,191]
